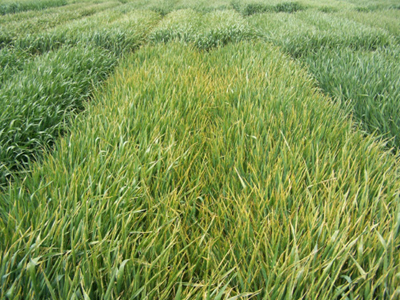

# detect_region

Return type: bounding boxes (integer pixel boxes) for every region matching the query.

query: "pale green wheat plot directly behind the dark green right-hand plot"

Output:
[249,11,393,58]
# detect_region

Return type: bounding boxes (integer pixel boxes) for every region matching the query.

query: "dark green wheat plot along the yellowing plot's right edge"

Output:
[304,47,400,150]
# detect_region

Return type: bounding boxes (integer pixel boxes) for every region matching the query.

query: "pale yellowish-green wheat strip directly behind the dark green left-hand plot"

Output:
[0,6,158,82]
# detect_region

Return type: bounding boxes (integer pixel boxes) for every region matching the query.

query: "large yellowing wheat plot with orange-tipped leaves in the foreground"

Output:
[0,43,400,299]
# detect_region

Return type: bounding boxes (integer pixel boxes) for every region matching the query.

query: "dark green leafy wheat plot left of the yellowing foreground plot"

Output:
[0,46,116,184]
